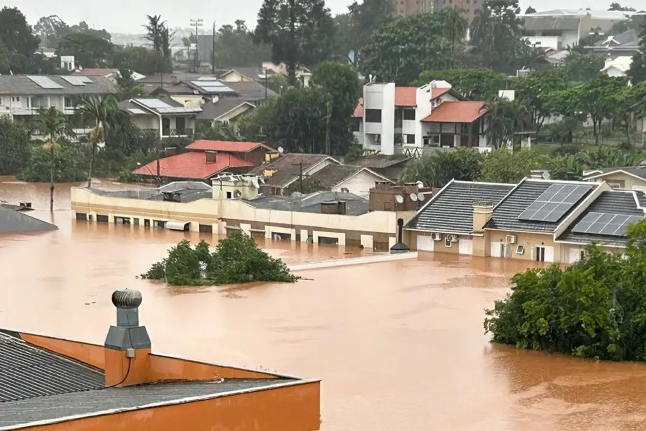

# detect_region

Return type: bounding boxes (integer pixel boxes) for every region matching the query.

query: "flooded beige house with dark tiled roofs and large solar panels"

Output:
[406,179,646,263]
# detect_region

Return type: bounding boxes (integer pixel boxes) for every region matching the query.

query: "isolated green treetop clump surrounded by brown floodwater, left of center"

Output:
[141,231,298,286]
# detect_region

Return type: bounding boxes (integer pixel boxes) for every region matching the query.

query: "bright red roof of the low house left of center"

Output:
[133,151,253,180]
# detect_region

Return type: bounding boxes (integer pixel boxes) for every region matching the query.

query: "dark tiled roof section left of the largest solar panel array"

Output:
[406,181,514,234]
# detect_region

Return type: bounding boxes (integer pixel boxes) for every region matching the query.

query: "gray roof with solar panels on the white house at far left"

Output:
[0,75,118,96]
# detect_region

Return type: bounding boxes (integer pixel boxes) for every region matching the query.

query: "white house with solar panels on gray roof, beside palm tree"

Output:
[119,99,202,139]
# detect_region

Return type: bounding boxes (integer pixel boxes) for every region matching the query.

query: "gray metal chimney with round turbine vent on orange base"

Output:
[104,289,150,387]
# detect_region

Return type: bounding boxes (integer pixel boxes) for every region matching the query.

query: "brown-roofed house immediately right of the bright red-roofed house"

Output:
[249,153,341,195]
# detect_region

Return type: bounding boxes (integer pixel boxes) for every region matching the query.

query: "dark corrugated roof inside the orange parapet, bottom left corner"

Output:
[0,332,105,404]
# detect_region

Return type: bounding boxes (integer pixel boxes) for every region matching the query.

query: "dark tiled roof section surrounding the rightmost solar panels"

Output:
[558,190,646,246]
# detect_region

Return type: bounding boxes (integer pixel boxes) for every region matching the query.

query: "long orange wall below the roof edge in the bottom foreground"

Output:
[25,382,321,431]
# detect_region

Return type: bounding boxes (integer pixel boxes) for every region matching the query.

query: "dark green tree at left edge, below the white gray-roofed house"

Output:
[0,115,30,175]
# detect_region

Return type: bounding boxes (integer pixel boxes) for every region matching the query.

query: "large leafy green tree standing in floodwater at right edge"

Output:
[484,222,646,361]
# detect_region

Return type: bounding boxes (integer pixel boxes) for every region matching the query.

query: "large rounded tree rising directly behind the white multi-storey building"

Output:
[360,13,453,85]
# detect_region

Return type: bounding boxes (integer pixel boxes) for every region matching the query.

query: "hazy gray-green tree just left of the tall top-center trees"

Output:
[215,20,271,68]
